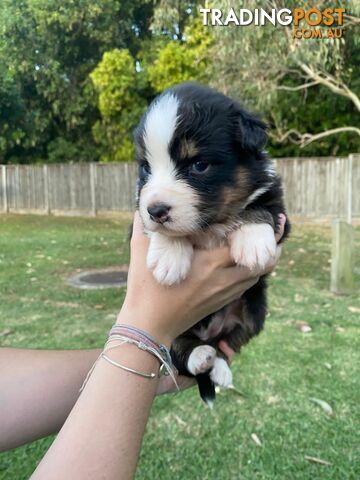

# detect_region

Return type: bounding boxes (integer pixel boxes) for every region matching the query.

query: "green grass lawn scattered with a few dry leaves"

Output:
[0,216,360,480]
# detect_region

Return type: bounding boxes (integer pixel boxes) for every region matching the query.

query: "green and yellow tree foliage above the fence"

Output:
[0,0,360,163]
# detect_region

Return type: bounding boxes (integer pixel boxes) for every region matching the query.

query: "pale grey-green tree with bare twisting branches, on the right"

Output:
[212,0,360,155]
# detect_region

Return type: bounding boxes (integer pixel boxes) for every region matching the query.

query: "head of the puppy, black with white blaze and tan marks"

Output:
[135,83,266,236]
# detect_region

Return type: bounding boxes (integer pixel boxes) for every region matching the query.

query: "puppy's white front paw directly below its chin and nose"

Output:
[147,234,193,285]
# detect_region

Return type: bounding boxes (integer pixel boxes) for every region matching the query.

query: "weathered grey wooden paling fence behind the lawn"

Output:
[0,155,360,218]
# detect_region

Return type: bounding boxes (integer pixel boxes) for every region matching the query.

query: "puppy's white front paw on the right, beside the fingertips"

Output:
[229,223,276,270]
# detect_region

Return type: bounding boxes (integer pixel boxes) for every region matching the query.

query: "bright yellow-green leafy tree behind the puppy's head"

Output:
[90,0,212,161]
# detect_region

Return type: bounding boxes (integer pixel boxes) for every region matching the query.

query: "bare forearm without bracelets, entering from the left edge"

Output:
[0,348,100,451]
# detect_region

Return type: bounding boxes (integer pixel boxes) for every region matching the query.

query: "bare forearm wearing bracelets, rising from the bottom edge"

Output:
[32,345,159,480]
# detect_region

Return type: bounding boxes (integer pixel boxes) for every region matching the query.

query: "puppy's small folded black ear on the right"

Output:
[237,110,268,150]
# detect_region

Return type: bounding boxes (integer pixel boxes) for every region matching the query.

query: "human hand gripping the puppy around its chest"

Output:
[118,213,285,346]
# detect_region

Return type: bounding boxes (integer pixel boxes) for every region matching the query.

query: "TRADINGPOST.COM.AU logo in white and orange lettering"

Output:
[199,8,345,39]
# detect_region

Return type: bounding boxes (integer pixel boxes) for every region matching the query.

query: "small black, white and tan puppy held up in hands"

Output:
[135,83,289,404]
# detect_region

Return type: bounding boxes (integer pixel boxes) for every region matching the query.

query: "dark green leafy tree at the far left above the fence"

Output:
[0,0,153,162]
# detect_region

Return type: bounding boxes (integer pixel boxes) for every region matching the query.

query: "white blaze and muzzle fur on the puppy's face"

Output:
[140,93,198,234]
